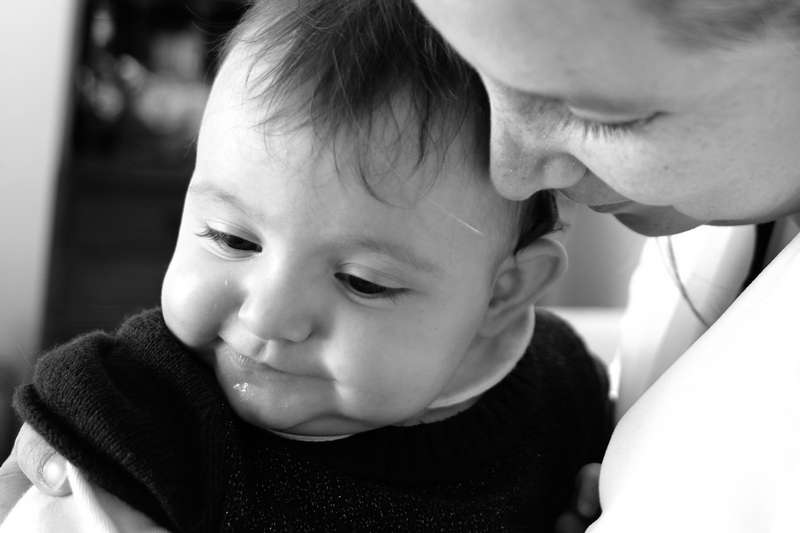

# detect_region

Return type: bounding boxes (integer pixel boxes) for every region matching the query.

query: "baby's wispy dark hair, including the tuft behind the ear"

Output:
[225,0,560,253]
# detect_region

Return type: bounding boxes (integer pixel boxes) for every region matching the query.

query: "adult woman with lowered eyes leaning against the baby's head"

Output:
[1,0,800,533]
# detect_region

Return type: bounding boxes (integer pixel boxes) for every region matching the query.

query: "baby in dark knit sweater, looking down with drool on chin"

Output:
[6,0,609,532]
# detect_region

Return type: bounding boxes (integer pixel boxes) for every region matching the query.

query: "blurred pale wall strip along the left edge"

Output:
[0,0,78,374]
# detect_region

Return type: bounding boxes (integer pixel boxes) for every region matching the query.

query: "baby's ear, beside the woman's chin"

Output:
[480,238,567,337]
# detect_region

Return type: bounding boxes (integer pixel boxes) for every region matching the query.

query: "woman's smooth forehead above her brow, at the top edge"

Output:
[418,0,688,85]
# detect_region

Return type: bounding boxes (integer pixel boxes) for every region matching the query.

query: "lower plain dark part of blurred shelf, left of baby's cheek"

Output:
[43,158,191,348]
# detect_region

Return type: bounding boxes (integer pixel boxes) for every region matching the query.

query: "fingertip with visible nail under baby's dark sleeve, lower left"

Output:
[14,424,72,496]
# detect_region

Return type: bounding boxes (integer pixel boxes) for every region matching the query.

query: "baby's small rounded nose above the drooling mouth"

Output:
[239,264,315,342]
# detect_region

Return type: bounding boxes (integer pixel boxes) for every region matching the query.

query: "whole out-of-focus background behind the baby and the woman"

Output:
[0,0,642,458]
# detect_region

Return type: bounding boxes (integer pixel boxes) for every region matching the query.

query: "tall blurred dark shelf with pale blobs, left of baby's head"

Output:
[42,0,244,349]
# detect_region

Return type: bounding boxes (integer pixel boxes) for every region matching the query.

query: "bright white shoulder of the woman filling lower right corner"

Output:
[589,217,800,533]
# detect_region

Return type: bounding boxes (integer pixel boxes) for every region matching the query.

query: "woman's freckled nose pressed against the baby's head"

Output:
[490,92,586,200]
